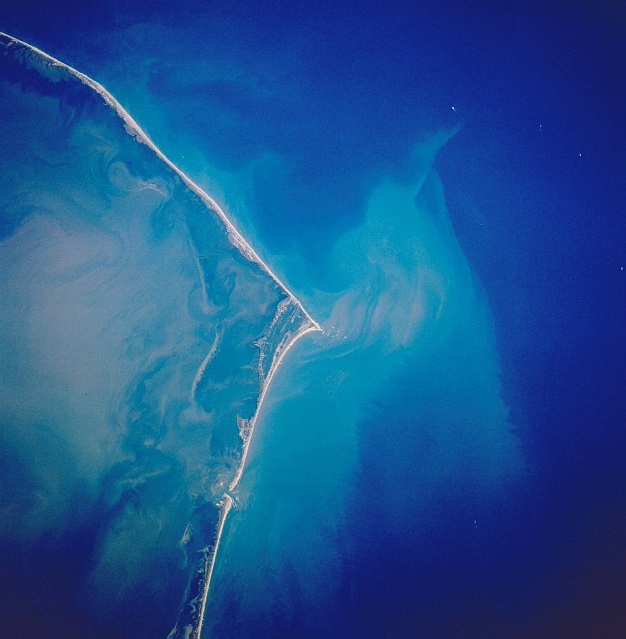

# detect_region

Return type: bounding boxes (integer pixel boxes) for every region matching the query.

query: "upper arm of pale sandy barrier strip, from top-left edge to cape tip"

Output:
[0,31,322,331]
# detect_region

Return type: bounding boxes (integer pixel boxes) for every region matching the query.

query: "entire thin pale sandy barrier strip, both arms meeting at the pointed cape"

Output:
[0,31,323,639]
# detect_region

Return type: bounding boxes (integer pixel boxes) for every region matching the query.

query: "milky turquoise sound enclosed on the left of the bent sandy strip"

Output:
[0,36,309,637]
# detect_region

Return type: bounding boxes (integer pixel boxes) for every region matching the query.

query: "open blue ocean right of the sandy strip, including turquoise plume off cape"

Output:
[0,0,626,639]
